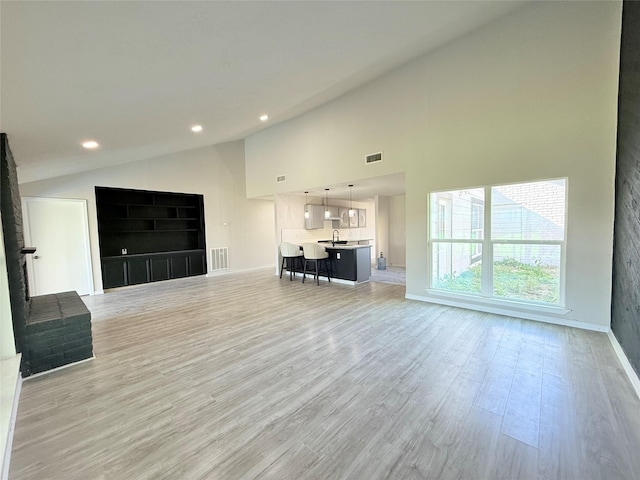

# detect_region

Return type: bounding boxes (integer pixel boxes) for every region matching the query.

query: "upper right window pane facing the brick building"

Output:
[491,180,566,240]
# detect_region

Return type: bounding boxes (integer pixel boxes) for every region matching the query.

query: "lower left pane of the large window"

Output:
[431,242,482,293]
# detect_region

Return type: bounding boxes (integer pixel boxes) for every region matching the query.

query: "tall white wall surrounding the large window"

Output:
[245,2,621,329]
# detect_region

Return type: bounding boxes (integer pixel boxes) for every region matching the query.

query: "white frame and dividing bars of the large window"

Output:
[427,177,569,308]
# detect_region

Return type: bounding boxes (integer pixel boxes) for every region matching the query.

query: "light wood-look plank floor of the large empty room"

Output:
[10,270,640,480]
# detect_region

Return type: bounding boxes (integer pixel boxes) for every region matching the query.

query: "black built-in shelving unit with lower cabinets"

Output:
[96,187,207,288]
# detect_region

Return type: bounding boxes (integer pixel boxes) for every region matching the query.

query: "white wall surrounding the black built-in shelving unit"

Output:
[20,141,275,291]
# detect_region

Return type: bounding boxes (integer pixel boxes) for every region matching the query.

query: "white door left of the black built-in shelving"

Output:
[22,197,93,296]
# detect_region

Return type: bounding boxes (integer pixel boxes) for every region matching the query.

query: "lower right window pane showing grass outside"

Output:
[493,244,561,304]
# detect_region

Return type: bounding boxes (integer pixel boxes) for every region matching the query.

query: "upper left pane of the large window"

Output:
[430,188,484,240]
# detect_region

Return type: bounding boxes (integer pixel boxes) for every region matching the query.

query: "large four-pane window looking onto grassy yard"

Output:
[429,179,566,305]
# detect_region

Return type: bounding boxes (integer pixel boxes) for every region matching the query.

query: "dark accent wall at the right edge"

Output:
[611,1,640,373]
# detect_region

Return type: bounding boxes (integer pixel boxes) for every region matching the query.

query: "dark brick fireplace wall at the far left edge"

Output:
[0,133,30,376]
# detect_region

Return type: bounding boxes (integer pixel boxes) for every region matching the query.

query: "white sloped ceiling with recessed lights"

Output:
[0,1,522,188]
